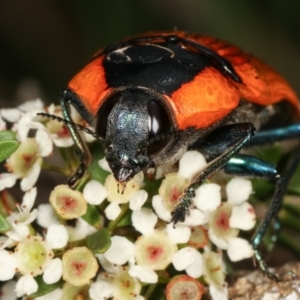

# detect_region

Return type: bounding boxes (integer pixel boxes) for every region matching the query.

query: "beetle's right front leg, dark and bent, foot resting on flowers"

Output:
[171,123,255,226]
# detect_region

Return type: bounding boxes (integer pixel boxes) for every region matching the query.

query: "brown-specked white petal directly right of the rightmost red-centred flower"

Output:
[229,202,256,230]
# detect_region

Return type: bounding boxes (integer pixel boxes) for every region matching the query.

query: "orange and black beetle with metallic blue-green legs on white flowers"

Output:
[41,31,300,280]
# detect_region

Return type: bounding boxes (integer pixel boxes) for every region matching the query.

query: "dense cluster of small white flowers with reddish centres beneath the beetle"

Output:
[0,100,256,300]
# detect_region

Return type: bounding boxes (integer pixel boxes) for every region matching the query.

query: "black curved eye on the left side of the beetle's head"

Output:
[95,94,122,139]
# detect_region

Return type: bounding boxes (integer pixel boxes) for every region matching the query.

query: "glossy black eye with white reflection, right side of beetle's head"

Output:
[148,100,172,155]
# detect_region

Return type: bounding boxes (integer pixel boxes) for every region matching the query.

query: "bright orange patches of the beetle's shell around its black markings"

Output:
[68,32,299,129]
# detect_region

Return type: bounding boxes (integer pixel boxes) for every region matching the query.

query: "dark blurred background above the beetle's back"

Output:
[0,0,300,107]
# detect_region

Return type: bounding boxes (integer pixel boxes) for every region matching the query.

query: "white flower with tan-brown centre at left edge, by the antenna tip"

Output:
[0,99,53,191]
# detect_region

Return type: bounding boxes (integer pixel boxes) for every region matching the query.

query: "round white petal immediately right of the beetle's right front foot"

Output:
[194,183,221,212]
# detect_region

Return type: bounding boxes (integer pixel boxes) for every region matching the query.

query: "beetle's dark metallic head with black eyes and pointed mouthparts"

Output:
[96,89,172,183]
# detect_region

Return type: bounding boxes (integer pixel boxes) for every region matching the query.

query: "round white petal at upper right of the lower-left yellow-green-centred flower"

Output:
[46,224,69,249]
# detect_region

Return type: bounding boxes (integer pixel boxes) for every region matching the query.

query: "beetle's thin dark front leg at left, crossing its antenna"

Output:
[60,93,92,188]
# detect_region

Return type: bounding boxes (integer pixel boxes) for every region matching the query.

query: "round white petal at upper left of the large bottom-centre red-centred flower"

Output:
[131,208,158,235]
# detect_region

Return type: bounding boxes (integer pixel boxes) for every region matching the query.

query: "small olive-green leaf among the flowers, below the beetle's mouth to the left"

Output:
[87,228,111,254]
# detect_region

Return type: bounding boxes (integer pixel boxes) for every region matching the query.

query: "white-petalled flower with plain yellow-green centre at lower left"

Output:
[0,225,68,297]
